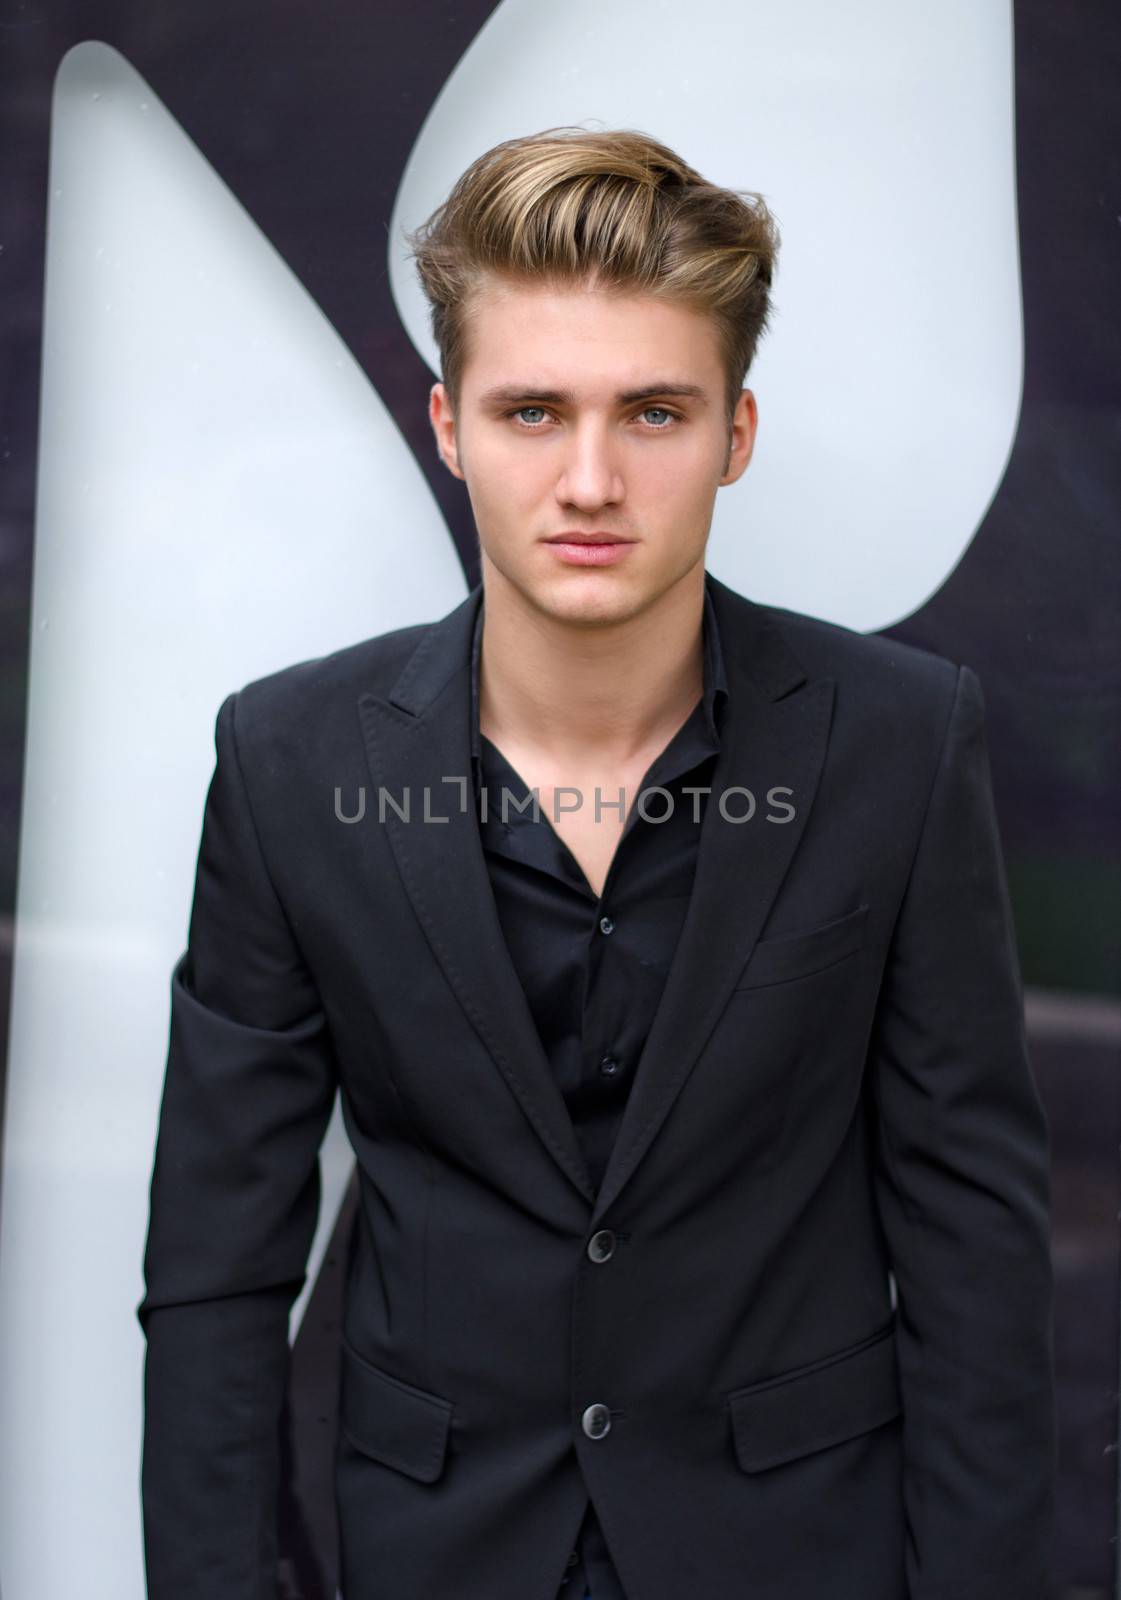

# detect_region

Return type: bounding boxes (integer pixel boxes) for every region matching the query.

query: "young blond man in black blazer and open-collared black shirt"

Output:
[139,130,1054,1600]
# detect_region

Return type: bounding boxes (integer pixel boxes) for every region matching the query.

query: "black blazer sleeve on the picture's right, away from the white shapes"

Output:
[870,666,1055,1600]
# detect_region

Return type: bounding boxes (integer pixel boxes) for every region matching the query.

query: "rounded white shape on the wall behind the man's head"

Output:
[390,0,1023,630]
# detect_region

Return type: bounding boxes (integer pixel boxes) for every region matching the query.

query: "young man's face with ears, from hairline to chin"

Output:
[429,275,756,622]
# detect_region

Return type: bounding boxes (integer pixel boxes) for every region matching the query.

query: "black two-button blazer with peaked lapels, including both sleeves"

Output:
[139,574,1054,1600]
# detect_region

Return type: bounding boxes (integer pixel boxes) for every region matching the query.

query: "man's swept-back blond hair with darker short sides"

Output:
[405,126,779,424]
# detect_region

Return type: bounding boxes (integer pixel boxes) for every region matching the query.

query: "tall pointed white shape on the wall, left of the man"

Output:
[0,42,465,1600]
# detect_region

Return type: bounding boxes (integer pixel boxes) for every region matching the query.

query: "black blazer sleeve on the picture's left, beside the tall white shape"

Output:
[138,694,336,1600]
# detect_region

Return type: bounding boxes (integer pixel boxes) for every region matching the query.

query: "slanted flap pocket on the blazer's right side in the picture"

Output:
[728,1315,902,1472]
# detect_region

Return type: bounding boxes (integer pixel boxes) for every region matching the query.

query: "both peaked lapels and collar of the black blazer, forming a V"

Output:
[358,574,833,1222]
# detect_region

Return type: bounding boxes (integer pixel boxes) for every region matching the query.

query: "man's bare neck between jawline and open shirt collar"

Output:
[478,558,705,768]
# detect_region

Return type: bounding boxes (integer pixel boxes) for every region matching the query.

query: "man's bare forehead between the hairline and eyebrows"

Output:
[462,274,723,395]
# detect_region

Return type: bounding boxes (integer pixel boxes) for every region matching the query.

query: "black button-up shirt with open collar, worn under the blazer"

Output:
[472,574,728,1600]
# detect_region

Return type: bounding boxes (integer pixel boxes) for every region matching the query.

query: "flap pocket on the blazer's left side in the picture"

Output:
[339,1338,453,1483]
